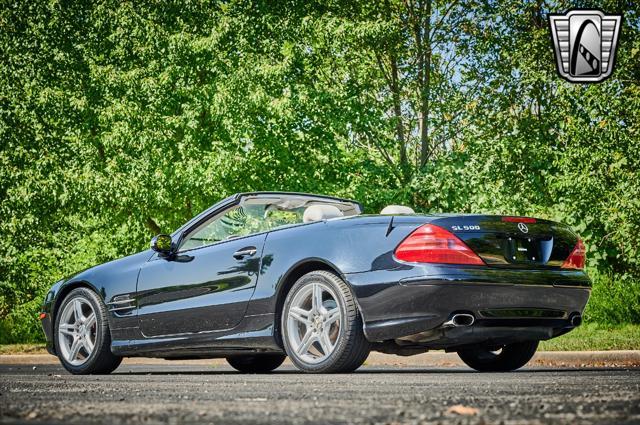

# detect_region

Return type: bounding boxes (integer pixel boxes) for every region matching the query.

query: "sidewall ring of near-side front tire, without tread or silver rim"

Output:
[53,288,109,374]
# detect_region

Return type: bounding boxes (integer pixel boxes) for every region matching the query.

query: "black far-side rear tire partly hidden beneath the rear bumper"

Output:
[458,341,538,372]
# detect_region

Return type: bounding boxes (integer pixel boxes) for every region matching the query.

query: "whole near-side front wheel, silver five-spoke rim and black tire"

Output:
[55,288,122,375]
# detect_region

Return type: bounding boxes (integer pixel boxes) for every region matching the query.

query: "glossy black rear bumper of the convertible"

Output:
[346,270,590,342]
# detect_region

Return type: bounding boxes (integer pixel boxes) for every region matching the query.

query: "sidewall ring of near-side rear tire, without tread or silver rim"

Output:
[281,272,353,371]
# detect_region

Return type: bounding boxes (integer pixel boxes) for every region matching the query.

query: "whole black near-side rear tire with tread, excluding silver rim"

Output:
[280,270,371,373]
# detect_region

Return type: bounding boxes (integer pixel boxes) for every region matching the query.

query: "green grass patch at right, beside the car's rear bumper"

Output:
[539,323,640,351]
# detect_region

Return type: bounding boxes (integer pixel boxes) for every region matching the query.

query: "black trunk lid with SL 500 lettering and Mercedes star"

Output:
[431,215,578,269]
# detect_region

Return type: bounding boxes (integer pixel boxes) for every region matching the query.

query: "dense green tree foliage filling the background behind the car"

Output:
[0,0,640,341]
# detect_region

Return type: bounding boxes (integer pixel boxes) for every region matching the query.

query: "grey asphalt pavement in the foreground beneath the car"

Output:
[0,364,640,424]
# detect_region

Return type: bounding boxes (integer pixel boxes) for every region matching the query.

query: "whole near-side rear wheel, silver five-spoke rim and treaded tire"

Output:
[281,270,370,373]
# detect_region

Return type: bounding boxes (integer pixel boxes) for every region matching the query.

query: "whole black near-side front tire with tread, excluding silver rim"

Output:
[54,288,122,375]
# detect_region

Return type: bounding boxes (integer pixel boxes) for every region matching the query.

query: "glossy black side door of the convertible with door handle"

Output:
[137,233,266,337]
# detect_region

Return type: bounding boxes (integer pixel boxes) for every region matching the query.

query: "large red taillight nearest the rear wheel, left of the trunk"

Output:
[395,224,484,265]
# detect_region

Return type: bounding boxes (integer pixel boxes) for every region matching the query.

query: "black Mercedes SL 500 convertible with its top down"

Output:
[40,192,591,374]
